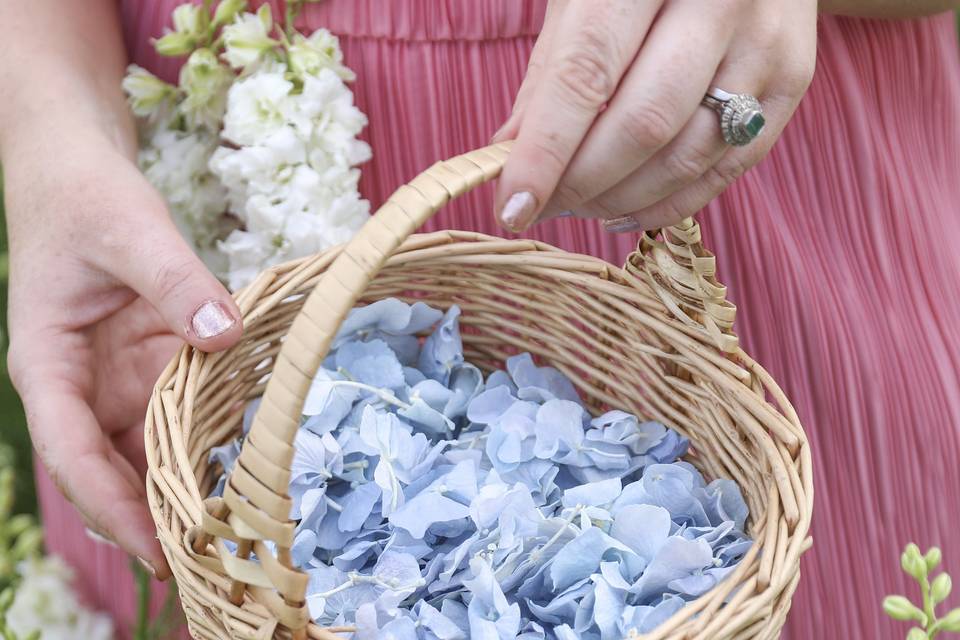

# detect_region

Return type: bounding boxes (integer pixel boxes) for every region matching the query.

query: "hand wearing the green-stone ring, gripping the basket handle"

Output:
[494,0,817,231]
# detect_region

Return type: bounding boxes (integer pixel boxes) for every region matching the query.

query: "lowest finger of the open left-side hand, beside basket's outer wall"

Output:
[21,371,169,578]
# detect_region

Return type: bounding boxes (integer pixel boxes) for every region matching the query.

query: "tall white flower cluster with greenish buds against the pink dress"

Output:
[124,0,370,289]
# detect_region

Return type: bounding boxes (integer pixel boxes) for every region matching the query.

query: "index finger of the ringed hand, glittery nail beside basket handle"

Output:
[496,0,659,231]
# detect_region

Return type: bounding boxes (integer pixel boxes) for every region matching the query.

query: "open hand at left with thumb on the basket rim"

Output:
[3,122,242,578]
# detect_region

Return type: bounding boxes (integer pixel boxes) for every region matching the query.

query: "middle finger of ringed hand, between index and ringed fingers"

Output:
[546,0,735,220]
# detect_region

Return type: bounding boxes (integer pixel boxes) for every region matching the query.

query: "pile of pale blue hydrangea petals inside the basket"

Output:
[211,298,751,640]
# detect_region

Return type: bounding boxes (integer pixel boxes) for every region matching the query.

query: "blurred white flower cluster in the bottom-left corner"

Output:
[7,556,114,640]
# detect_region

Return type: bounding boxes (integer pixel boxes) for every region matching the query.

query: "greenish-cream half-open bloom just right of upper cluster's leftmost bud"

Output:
[180,49,234,131]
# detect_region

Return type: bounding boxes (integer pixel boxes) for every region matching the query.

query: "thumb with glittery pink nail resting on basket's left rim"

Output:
[113,218,243,351]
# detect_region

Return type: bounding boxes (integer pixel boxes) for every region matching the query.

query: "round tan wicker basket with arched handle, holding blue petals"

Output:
[145,143,813,640]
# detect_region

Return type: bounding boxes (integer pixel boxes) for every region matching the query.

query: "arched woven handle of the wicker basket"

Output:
[208,142,736,639]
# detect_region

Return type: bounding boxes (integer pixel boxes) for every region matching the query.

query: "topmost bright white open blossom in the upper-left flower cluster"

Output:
[223,65,294,145]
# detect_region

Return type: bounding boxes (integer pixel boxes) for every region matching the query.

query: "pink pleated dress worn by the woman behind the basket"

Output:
[35,0,960,640]
